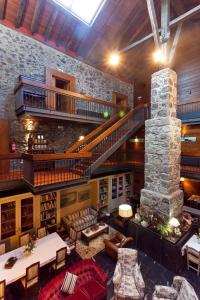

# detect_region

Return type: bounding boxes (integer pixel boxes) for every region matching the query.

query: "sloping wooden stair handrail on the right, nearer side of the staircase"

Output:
[79,104,148,153]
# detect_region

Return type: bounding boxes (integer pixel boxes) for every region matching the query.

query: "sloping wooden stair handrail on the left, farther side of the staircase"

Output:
[66,114,118,153]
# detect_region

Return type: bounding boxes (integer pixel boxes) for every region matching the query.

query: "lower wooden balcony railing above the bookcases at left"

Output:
[0,153,92,188]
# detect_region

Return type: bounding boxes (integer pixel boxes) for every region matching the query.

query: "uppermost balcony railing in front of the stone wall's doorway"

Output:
[15,80,117,123]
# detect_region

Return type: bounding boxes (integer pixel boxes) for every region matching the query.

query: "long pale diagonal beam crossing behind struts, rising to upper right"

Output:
[119,4,200,52]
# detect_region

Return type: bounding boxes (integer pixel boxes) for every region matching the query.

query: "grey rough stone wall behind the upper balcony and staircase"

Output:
[0,24,133,150]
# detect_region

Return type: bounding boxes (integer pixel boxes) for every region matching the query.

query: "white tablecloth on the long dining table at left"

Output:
[0,232,70,285]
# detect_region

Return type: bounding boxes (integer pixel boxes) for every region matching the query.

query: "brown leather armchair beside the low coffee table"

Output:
[104,232,133,260]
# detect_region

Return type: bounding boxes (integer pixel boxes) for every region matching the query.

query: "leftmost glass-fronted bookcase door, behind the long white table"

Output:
[1,201,16,240]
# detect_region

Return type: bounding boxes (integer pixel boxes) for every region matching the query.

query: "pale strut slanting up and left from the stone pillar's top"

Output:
[146,0,160,48]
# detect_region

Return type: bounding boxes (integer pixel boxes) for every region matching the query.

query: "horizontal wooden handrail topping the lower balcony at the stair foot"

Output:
[22,151,92,161]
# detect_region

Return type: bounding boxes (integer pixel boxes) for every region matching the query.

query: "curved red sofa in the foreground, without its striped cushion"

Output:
[38,259,108,300]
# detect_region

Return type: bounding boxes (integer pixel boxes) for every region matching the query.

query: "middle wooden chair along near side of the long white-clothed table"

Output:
[21,262,40,290]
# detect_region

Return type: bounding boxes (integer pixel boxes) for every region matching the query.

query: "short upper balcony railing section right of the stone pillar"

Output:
[177,99,200,124]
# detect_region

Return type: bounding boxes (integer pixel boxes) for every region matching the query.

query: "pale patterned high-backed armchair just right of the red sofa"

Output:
[113,248,145,300]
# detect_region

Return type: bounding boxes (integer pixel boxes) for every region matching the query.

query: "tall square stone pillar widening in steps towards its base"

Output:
[140,68,183,220]
